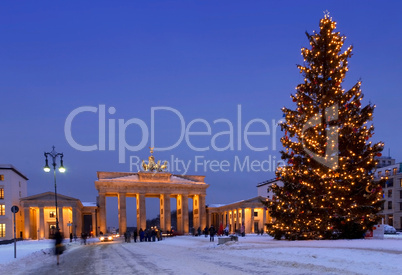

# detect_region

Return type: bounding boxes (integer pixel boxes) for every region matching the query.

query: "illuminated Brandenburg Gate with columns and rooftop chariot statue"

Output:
[95,151,209,233]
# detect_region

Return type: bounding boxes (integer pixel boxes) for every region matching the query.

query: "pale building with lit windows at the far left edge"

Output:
[0,164,28,240]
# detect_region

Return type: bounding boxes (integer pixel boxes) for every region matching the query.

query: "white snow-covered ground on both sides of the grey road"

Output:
[0,235,402,275]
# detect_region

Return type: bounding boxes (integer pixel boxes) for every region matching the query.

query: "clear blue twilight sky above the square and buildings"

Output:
[0,1,402,229]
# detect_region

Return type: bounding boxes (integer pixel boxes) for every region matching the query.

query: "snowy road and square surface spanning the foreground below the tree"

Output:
[5,236,402,275]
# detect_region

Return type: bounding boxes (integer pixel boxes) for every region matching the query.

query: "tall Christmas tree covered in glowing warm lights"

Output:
[266,13,384,240]
